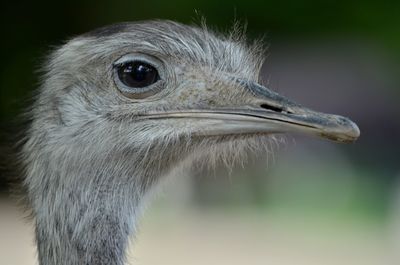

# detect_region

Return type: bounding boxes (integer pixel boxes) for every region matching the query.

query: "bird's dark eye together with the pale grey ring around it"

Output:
[113,54,165,99]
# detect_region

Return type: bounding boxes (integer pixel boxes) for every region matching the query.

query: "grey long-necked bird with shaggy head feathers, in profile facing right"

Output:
[21,21,359,265]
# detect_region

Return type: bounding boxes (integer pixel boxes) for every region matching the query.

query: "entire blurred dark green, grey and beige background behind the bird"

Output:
[0,0,400,265]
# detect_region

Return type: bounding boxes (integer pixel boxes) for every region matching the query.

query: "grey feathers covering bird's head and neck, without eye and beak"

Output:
[21,21,272,265]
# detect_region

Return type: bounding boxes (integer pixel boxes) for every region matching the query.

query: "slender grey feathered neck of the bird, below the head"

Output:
[36,169,140,265]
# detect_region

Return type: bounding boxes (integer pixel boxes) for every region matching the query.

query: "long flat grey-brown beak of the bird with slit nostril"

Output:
[146,79,360,143]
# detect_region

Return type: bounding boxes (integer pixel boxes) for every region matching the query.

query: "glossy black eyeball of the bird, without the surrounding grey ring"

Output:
[118,61,159,87]
